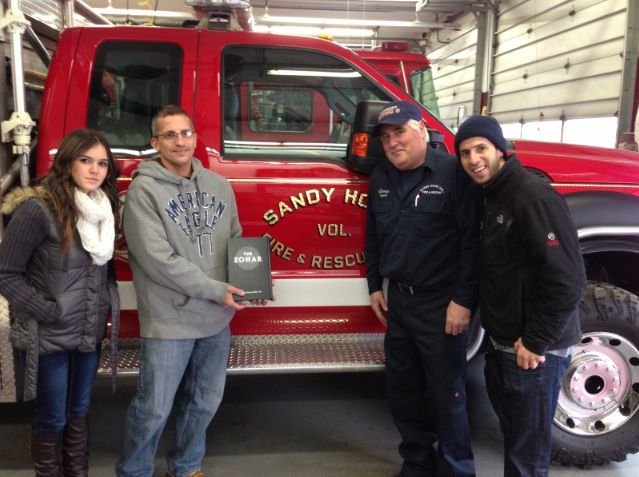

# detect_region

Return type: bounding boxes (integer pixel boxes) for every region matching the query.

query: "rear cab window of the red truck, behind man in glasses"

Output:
[87,41,182,157]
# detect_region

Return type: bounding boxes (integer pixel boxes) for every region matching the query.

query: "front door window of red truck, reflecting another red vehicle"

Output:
[222,46,390,164]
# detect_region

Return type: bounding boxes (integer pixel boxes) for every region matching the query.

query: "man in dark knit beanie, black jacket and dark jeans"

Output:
[455,116,586,477]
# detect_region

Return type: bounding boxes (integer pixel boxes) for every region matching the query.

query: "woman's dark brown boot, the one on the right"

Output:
[62,414,89,477]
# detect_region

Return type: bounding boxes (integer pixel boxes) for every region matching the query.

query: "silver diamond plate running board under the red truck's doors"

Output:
[98,333,385,376]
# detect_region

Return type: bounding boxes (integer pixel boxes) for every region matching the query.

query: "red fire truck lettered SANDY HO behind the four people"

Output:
[0,1,639,466]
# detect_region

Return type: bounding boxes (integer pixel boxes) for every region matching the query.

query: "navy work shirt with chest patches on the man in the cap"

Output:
[366,146,479,308]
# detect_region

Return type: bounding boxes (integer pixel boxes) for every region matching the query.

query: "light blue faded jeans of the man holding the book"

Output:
[115,326,231,477]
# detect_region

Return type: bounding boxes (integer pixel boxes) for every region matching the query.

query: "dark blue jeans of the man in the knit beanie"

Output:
[485,348,572,477]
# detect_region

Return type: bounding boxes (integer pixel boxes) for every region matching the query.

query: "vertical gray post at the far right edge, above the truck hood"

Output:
[616,0,639,144]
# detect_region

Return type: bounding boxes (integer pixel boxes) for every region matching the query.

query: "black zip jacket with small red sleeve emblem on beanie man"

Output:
[480,154,586,356]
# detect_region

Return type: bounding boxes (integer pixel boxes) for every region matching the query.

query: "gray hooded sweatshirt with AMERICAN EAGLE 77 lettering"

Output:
[122,158,242,339]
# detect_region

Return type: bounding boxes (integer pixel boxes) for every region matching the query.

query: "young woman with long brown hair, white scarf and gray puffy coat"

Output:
[0,129,120,477]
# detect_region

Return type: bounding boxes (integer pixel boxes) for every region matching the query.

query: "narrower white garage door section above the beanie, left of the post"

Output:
[426,14,477,127]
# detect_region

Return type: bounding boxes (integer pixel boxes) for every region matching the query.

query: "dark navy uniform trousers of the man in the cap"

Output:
[384,285,475,477]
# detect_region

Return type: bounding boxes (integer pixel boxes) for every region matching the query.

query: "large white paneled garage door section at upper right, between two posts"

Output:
[490,0,628,123]
